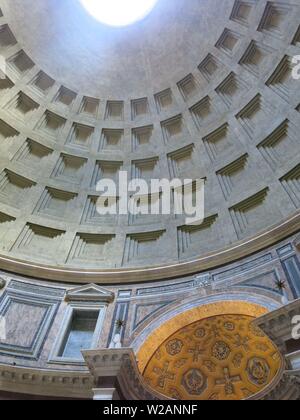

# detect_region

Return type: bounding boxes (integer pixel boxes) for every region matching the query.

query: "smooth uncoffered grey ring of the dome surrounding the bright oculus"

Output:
[3,0,232,97]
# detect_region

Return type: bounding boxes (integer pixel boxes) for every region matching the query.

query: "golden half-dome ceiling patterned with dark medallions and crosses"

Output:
[144,315,281,400]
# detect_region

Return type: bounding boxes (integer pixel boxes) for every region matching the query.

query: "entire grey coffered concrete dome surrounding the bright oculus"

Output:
[0,0,299,284]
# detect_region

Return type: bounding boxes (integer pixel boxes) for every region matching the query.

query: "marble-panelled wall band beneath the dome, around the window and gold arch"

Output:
[0,233,300,370]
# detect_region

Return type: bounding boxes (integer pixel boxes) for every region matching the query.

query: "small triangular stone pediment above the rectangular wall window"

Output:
[66,284,115,302]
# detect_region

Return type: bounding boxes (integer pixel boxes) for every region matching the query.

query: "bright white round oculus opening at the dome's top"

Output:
[80,0,158,26]
